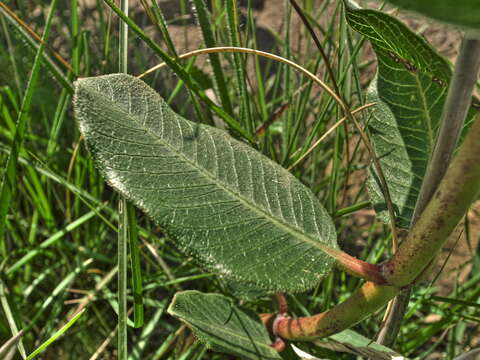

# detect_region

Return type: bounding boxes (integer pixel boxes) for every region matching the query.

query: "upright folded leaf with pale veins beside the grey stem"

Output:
[346,3,474,228]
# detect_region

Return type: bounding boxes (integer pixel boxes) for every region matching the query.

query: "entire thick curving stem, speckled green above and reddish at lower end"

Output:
[262,113,480,340]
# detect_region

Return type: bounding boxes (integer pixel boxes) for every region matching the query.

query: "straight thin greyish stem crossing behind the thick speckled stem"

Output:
[377,34,480,346]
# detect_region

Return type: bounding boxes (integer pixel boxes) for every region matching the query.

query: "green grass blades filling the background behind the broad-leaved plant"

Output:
[0,0,480,359]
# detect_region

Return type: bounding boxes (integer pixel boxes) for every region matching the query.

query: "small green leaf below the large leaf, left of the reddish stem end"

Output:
[168,291,281,360]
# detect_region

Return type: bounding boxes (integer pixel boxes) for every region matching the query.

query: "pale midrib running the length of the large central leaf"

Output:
[89,84,337,256]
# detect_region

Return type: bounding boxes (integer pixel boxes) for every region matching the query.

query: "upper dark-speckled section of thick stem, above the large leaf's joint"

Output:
[384,117,480,286]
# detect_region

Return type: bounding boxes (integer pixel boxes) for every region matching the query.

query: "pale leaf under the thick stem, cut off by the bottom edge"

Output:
[315,330,407,360]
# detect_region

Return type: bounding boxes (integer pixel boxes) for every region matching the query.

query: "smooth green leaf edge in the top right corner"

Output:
[380,0,480,29]
